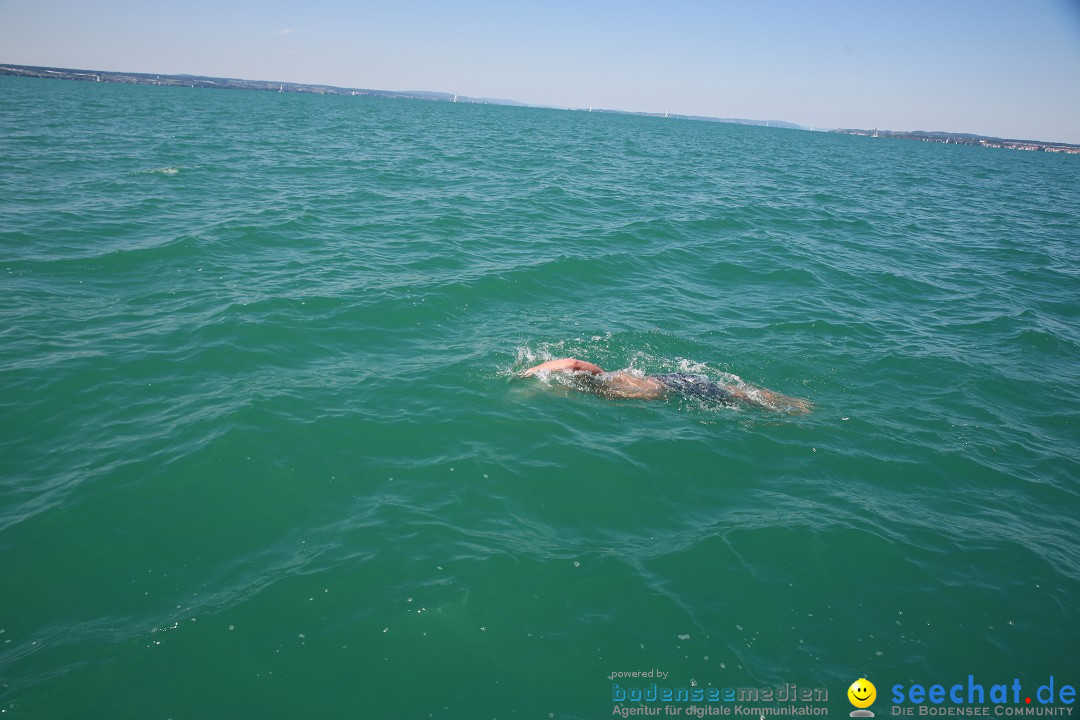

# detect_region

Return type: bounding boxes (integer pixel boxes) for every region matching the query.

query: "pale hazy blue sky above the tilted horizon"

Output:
[0,0,1080,142]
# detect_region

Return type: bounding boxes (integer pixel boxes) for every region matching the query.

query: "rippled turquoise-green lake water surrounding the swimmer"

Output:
[0,78,1080,720]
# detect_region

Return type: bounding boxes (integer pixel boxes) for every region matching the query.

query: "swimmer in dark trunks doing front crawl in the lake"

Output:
[522,357,810,415]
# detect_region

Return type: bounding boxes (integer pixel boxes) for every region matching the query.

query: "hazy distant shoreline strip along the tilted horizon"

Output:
[0,64,1080,154]
